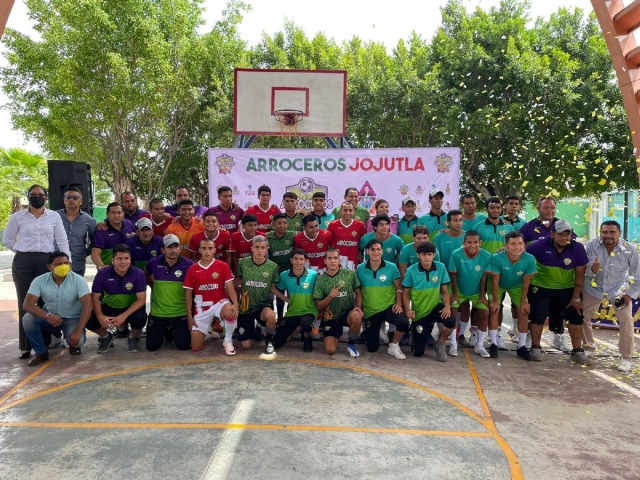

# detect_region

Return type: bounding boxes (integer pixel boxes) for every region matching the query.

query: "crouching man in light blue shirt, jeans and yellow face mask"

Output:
[22,251,93,367]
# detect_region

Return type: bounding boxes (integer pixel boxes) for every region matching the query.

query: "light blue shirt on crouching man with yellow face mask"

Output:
[28,272,91,318]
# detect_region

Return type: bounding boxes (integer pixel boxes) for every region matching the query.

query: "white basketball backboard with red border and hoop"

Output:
[233,68,347,137]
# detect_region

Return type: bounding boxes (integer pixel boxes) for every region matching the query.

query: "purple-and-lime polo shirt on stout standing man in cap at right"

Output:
[527,237,589,289]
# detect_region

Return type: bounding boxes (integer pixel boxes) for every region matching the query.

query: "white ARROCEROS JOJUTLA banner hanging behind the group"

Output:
[209,148,460,216]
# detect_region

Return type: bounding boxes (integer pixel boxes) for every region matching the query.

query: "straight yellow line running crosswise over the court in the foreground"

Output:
[0,422,494,438]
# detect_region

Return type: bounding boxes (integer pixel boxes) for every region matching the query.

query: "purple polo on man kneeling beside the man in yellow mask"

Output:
[91,266,147,308]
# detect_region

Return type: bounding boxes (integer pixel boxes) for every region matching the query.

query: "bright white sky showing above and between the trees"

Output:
[0,0,596,152]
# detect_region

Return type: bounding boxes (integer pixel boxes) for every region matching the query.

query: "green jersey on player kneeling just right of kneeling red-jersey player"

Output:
[238,257,278,314]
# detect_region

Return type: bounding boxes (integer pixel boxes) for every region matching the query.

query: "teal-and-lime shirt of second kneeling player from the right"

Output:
[356,260,400,318]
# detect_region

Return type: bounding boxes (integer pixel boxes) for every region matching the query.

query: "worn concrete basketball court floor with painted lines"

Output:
[0,258,640,480]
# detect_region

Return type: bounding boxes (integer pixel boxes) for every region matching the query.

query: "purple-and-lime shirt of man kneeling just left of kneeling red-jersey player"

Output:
[146,255,193,318]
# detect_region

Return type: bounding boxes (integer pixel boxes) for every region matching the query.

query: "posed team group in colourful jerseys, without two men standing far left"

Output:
[5,185,640,371]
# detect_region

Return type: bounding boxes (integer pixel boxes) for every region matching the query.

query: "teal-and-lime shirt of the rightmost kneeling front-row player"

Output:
[402,260,450,321]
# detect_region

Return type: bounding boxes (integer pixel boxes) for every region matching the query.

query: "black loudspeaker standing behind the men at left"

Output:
[47,160,94,215]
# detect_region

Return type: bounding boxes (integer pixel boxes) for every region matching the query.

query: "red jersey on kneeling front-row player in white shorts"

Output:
[183,260,233,315]
